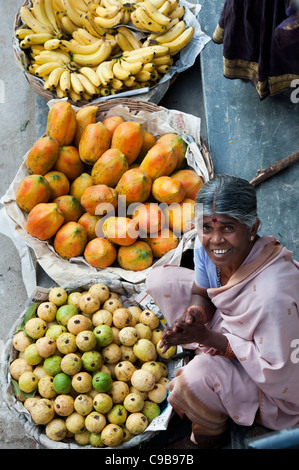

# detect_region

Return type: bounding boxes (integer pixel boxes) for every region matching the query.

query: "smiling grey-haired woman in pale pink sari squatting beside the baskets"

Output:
[146,175,299,448]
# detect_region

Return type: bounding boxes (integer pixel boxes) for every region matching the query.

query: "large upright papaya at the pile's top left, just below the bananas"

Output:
[46,101,77,147]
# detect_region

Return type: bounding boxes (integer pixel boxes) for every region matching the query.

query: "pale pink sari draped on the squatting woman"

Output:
[147,237,299,435]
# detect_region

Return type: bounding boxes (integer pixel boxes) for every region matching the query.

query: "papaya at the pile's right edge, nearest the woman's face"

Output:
[165,198,195,236]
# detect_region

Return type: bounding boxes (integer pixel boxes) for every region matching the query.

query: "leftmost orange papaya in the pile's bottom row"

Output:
[54,222,87,259]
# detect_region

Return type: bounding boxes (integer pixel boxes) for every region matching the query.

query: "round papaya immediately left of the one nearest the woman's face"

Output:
[132,201,166,236]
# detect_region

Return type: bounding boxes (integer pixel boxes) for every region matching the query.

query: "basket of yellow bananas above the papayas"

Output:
[13,0,209,105]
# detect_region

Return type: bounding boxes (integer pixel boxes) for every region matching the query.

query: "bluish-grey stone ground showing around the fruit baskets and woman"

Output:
[0,0,299,449]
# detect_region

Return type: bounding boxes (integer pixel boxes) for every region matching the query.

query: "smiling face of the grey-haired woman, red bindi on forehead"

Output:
[198,214,256,271]
